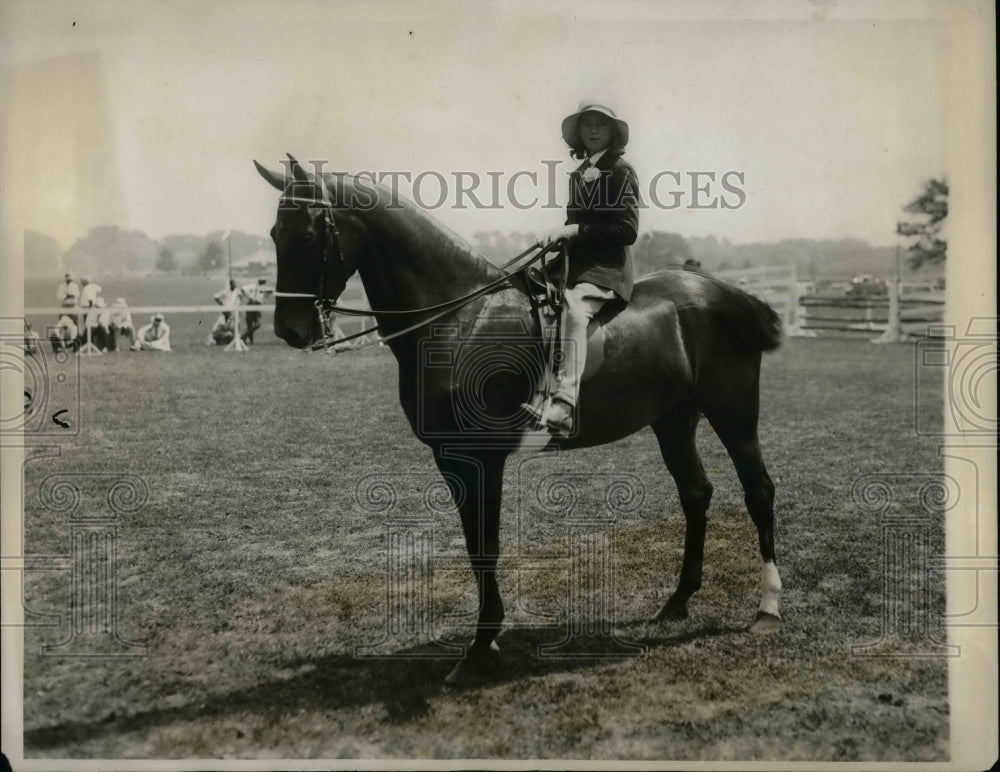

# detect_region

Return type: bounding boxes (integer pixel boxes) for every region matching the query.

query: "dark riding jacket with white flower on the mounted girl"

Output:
[566,150,639,301]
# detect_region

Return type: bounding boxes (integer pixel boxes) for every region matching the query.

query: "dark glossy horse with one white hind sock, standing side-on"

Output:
[254,155,782,676]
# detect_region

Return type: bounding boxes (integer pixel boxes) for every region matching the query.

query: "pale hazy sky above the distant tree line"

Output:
[0,0,947,247]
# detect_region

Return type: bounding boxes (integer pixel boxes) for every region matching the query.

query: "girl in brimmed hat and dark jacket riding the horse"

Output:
[540,101,639,436]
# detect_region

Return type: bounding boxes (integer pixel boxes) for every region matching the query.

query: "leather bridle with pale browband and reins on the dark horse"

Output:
[274,191,568,354]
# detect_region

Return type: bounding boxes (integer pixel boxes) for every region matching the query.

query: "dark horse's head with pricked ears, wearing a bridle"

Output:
[254,156,368,348]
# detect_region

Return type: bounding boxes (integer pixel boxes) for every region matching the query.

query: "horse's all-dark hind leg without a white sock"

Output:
[652,412,712,620]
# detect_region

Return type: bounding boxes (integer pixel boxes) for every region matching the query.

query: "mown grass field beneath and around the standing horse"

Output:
[24,328,948,761]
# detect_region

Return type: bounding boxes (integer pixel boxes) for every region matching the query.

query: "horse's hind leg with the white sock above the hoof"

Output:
[705,392,781,633]
